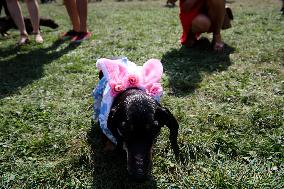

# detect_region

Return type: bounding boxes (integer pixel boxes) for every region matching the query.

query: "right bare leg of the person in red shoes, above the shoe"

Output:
[77,0,88,32]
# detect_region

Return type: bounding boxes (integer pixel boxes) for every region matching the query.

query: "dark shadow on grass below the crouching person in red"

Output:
[161,38,235,96]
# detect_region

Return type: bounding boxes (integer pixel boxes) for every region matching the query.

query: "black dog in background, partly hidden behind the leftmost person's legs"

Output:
[0,17,58,36]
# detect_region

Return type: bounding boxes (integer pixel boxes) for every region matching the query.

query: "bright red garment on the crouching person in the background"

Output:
[179,0,205,44]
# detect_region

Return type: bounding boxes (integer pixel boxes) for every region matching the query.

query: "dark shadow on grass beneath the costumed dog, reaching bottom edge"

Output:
[88,123,157,189]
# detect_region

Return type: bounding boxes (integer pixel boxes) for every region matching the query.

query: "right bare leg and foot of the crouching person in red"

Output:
[206,0,225,51]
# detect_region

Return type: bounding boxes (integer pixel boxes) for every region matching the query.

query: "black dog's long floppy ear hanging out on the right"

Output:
[155,106,179,159]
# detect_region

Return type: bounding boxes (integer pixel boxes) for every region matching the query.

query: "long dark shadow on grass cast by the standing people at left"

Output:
[0,40,79,99]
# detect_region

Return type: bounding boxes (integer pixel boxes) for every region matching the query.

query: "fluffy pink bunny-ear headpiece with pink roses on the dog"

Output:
[96,58,163,99]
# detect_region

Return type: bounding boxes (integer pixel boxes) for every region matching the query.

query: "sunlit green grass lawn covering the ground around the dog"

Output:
[0,0,284,189]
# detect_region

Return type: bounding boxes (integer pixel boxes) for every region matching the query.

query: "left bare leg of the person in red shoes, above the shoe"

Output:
[64,0,80,32]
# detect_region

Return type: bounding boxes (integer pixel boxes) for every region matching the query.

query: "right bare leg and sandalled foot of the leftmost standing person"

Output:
[26,0,43,43]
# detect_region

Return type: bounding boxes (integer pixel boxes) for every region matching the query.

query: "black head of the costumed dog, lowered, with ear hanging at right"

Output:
[108,88,178,181]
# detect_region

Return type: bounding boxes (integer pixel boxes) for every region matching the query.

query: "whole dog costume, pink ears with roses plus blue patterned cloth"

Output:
[93,58,163,144]
